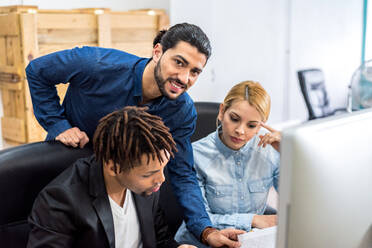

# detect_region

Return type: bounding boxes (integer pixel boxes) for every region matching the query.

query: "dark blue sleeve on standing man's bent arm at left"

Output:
[26,47,96,138]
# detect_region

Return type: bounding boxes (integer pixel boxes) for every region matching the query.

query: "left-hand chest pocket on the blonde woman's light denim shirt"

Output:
[205,184,233,214]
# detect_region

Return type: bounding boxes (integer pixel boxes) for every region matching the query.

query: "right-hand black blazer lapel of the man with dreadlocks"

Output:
[132,193,156,248]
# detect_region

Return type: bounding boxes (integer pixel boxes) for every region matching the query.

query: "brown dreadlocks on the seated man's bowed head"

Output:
[93,106,177,173]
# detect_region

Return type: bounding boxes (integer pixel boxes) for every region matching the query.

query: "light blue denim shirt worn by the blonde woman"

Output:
[176,129,280,247]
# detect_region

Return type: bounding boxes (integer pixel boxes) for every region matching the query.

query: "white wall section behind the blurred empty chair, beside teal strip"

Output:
[289,0,363,118]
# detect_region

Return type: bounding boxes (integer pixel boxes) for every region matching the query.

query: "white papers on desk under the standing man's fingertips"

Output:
[238,226,277,248]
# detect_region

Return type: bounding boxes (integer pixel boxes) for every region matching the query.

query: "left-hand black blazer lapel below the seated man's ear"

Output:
[89,158,115,248]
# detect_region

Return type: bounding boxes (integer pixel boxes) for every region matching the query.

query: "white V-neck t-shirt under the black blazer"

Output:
[109,189,142,248]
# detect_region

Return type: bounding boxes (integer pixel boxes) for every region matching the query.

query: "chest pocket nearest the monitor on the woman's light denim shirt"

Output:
[248,178,272,214]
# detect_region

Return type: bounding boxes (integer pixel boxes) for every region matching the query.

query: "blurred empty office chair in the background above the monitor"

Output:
[297,69,347,120]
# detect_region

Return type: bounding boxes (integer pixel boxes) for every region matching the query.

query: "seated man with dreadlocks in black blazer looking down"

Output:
[27,107,194,248]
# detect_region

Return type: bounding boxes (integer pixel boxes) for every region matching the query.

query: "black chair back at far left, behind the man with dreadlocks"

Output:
[0,141,92,248]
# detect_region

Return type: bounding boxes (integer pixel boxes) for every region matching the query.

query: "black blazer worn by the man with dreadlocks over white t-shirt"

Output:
[27,156,178,248]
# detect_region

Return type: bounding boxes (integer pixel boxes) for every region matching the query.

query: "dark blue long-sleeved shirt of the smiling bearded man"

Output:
[26,47,211,236]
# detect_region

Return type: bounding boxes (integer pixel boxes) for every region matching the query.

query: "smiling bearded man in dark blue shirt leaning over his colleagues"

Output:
[26,23,244,247]
